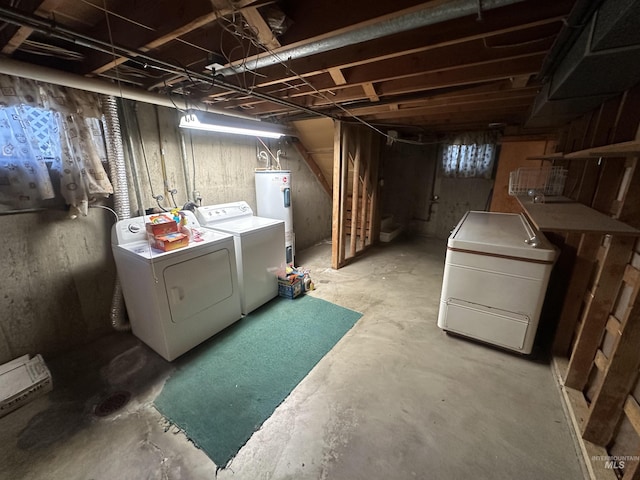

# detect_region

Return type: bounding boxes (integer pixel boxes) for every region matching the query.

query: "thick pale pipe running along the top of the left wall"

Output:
[0,58,255,120]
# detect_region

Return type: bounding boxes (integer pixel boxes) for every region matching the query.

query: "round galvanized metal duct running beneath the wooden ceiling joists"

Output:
[215,0,524,76]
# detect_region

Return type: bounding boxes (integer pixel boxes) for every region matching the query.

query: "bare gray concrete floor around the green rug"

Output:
[0,238,583,480]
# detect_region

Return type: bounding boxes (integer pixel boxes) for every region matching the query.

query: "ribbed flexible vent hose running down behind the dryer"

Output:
[102,96,131,332]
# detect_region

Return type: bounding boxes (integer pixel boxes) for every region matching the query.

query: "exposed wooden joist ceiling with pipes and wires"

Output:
[0,0,616,135]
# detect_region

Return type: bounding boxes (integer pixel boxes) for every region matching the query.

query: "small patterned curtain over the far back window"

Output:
[442,132,497,179]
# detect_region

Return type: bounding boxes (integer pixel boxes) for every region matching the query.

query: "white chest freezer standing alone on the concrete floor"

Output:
[438,211,558,354]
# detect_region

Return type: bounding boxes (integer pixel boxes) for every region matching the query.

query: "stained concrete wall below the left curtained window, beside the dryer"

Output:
[0,208,116,363]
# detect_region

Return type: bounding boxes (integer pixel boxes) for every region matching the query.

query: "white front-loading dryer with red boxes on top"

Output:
[111,211,242,361]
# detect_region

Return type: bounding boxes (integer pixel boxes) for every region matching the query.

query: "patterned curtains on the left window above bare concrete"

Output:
[0,75,113,215]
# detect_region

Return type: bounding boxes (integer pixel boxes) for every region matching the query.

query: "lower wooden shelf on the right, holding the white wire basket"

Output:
[516,195,640,237]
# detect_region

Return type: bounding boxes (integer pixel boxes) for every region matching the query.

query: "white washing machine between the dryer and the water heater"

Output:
[196,201,285,315]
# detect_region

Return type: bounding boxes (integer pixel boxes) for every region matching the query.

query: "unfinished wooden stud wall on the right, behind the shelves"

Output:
[553,83,640,480]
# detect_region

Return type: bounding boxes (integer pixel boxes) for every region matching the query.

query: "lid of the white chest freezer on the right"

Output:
[447,211,557,263]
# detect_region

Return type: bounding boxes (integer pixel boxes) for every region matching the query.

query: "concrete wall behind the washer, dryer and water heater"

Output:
[129,104,331,251]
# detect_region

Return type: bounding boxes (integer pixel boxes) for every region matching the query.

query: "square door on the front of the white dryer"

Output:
[164,248,233,323]
